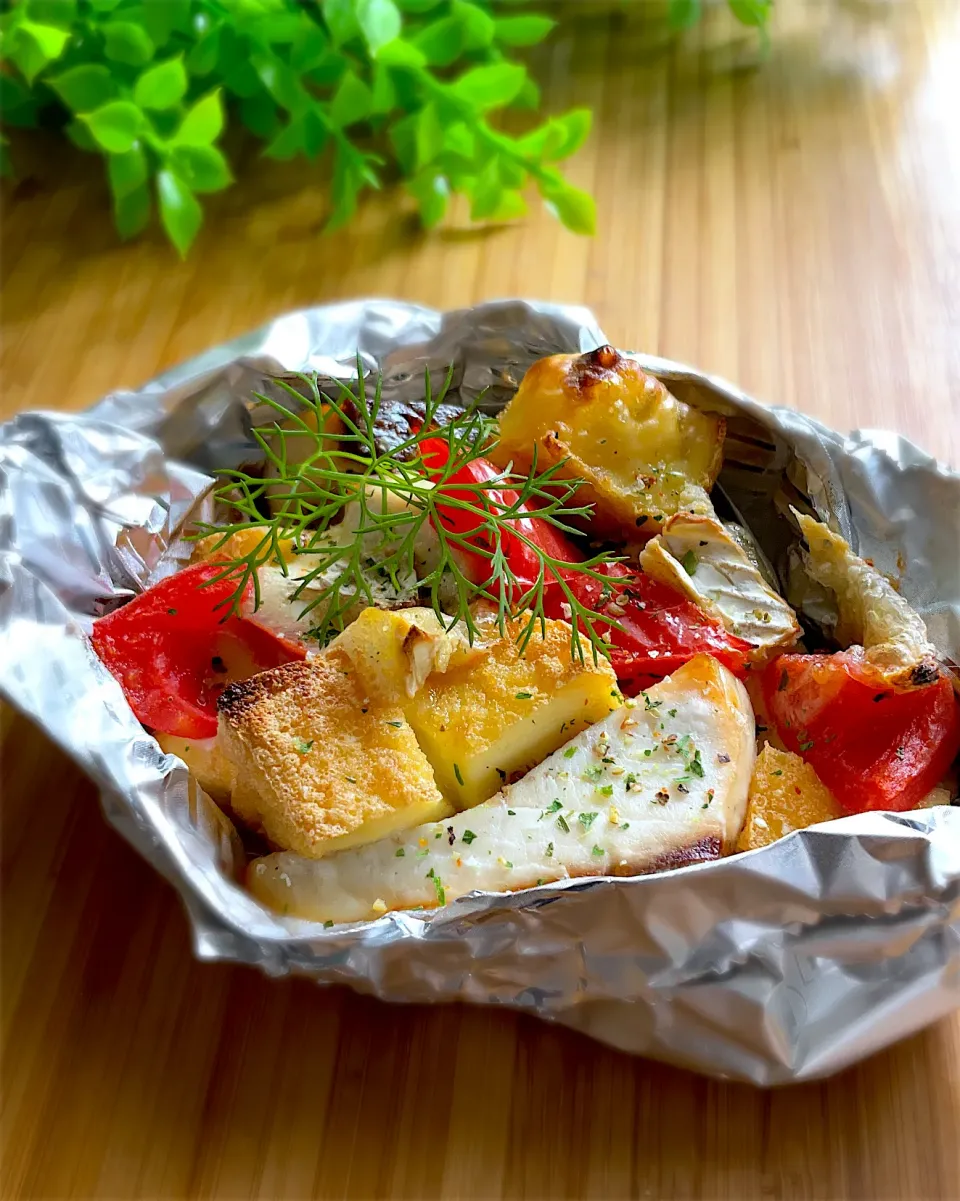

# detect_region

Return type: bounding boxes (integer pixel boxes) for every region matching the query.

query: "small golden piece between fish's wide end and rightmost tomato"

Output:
[738,743,843,850]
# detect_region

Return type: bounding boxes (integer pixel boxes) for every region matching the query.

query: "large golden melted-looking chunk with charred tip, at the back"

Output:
[491,346,725,536]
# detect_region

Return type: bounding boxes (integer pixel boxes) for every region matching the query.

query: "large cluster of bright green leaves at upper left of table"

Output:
[0,0,596,255]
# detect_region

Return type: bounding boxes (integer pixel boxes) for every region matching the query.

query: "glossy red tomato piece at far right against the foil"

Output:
[763,651,960,813]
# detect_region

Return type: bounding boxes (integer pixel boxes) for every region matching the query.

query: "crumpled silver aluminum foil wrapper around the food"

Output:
[0,300,960,1085]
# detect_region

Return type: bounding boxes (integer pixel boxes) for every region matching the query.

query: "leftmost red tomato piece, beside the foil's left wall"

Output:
[91,563,305,739]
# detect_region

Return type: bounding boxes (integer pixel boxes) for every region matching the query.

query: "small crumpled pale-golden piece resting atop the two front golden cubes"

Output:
[330,608,487,703]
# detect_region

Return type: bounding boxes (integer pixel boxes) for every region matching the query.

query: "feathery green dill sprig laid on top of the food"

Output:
[193,362,618,662]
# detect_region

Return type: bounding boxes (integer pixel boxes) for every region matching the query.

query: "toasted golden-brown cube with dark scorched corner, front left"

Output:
[219,655,453,859]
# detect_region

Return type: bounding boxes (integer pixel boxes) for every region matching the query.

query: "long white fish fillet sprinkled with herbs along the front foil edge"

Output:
[248,656,756,922]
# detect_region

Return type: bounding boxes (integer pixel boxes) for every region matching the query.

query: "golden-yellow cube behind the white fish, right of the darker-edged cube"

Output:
[405,621,622,809]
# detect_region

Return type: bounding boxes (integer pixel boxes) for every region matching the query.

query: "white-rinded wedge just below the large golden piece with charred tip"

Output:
[640,513,800,663]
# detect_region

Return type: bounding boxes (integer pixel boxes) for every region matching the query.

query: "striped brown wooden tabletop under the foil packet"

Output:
[0,0,960,1199]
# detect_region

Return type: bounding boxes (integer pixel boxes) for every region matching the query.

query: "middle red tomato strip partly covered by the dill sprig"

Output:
[421,437,752,688]
